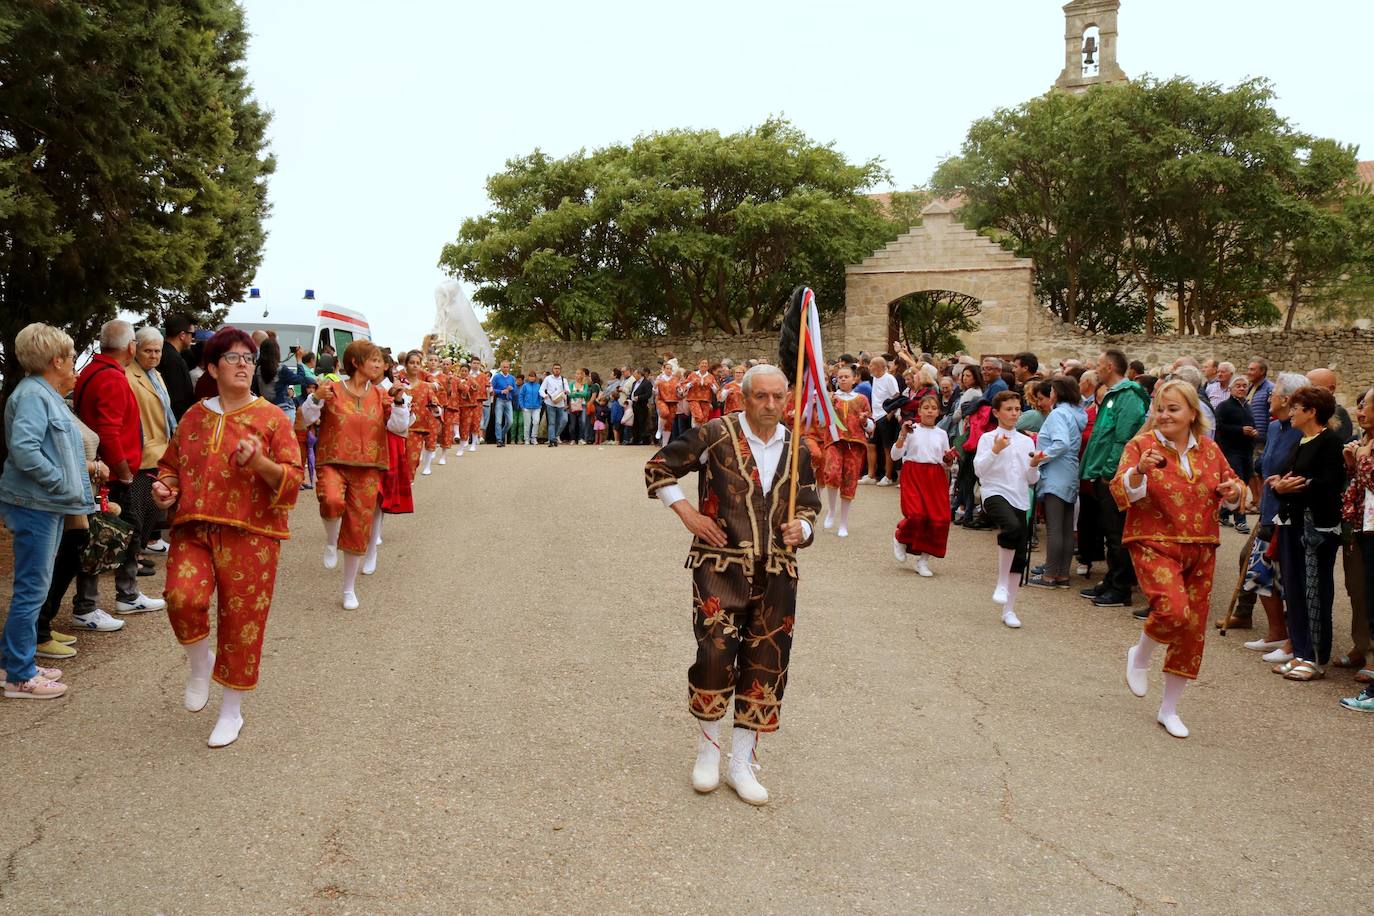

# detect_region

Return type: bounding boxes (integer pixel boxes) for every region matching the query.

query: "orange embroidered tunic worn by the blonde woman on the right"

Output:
[1112,433,1237,544]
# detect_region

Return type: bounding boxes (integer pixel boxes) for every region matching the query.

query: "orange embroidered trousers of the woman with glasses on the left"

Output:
[165,522,282,691]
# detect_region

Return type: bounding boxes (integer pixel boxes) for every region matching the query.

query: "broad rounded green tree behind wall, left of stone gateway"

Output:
[440,119,907,339]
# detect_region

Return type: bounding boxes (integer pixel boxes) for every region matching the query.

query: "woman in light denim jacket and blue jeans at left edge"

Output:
[0,323,100,699]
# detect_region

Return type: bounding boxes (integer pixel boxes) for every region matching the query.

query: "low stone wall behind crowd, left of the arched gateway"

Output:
[521,316,845,379]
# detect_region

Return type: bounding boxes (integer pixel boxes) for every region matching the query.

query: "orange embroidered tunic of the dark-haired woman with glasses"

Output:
[158,398,304,540]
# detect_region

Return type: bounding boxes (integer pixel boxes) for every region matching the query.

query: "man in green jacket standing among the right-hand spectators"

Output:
[1080,349,1150,607]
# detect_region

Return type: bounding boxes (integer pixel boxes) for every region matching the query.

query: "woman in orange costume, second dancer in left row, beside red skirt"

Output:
[300,341,411,611]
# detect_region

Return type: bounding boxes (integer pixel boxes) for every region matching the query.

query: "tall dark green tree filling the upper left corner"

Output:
[0,0,273,393]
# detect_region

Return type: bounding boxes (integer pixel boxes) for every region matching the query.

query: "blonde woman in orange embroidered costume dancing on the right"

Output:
[1112,380,1243,737]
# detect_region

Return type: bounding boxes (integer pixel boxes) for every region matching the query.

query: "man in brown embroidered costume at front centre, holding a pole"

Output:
[644,365,820,805]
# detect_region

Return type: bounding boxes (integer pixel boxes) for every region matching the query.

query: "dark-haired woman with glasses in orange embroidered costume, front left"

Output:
[153,328,304,747]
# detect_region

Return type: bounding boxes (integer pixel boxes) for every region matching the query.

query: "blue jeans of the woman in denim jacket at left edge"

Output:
[0,503,63,684]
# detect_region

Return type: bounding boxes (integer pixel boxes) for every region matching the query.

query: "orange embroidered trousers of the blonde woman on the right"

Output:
[1127,541,1216,678]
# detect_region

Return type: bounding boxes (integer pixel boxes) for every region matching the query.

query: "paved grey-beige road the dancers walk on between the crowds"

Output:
[0,446,1374,913]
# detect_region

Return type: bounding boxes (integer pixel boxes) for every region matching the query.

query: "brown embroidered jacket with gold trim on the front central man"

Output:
[644,415,820,578]
